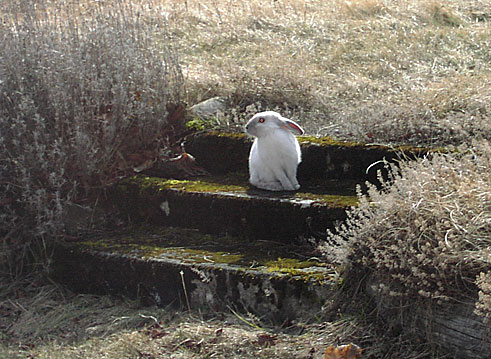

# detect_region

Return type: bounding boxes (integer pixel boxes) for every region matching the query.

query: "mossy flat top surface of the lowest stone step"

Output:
[74,228,334,281]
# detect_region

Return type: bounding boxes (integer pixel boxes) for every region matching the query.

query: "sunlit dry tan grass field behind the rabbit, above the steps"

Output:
[159,0,491,145]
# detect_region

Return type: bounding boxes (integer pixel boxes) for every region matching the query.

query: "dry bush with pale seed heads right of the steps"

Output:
[324,142,491,315]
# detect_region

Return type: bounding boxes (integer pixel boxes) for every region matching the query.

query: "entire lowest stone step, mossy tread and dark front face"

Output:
[53,226,339,323]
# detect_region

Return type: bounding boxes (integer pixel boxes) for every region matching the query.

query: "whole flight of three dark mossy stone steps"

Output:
[55,133,424,322]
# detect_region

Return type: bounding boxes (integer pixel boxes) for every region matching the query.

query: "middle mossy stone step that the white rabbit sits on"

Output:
[109,173,357,241]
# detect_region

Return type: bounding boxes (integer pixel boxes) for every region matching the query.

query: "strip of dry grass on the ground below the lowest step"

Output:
[0,285,438,359]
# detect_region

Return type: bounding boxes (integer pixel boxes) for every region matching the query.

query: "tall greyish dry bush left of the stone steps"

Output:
[0,0,182,278]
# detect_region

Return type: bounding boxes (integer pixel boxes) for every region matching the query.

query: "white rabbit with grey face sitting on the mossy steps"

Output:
[245,111,304,191]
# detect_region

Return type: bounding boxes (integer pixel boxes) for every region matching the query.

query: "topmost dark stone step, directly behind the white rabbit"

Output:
[184,132,430,183]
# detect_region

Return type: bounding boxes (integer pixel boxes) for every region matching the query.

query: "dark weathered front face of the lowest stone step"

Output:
[53,238,336,323]
